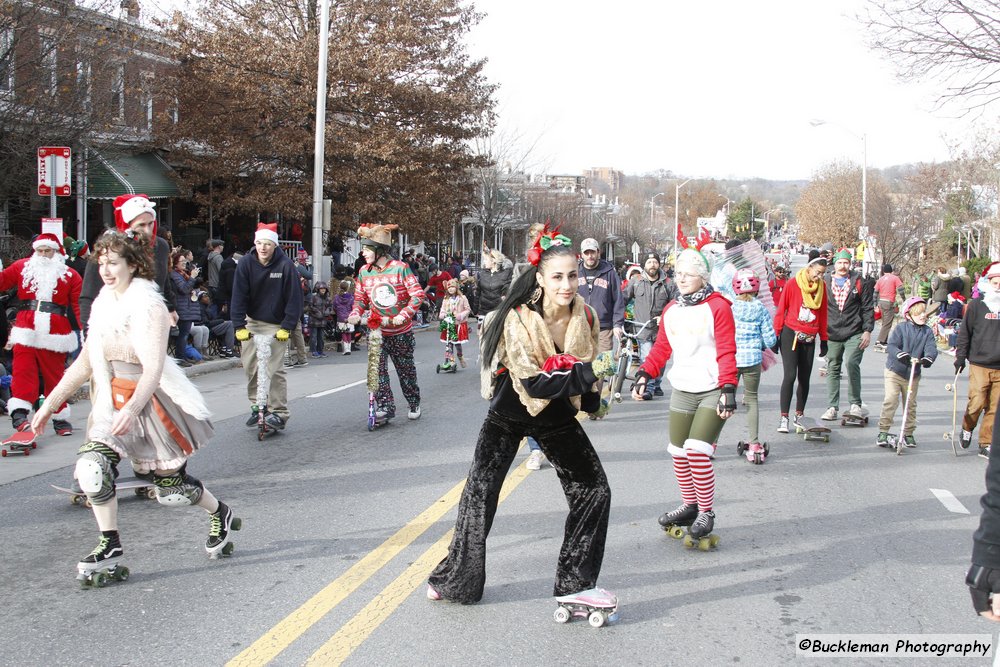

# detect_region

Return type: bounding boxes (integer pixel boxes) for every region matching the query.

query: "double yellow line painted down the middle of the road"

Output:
[227,452,530,667]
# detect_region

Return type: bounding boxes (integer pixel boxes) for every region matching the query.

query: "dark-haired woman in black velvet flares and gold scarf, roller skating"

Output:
[427,230,617,607]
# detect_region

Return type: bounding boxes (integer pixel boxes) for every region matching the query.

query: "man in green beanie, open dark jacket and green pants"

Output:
[822,248,875,421]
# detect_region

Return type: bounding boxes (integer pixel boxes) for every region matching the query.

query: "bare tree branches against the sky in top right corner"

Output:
[862,0,1000,112]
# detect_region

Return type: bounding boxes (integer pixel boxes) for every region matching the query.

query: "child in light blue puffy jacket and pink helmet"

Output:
[733,269,778,463]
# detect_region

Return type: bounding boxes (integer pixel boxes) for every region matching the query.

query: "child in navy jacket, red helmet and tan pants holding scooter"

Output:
[875,296,937,447]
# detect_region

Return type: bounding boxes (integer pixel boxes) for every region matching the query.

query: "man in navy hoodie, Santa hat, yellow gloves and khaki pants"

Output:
[229,223,302,429]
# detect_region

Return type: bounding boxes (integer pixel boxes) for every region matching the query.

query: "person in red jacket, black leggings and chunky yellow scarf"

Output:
[774,250,827,433]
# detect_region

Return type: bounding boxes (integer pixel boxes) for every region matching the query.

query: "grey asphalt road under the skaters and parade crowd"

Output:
[0,284,993,665]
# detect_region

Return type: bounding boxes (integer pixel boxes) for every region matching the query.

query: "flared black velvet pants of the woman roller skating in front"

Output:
[429,410,611,603]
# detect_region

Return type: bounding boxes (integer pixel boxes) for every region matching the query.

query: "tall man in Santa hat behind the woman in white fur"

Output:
[80,195,177,332]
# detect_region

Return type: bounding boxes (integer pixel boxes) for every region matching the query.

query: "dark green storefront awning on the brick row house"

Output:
[87,149,181,199]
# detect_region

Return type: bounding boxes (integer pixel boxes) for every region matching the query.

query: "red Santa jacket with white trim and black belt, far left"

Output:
[0,257,83,352]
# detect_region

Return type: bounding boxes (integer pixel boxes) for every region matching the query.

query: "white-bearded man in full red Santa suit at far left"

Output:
[0,234,82,435]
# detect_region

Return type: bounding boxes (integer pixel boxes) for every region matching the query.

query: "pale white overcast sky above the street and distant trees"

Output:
[470,0,984,179]
